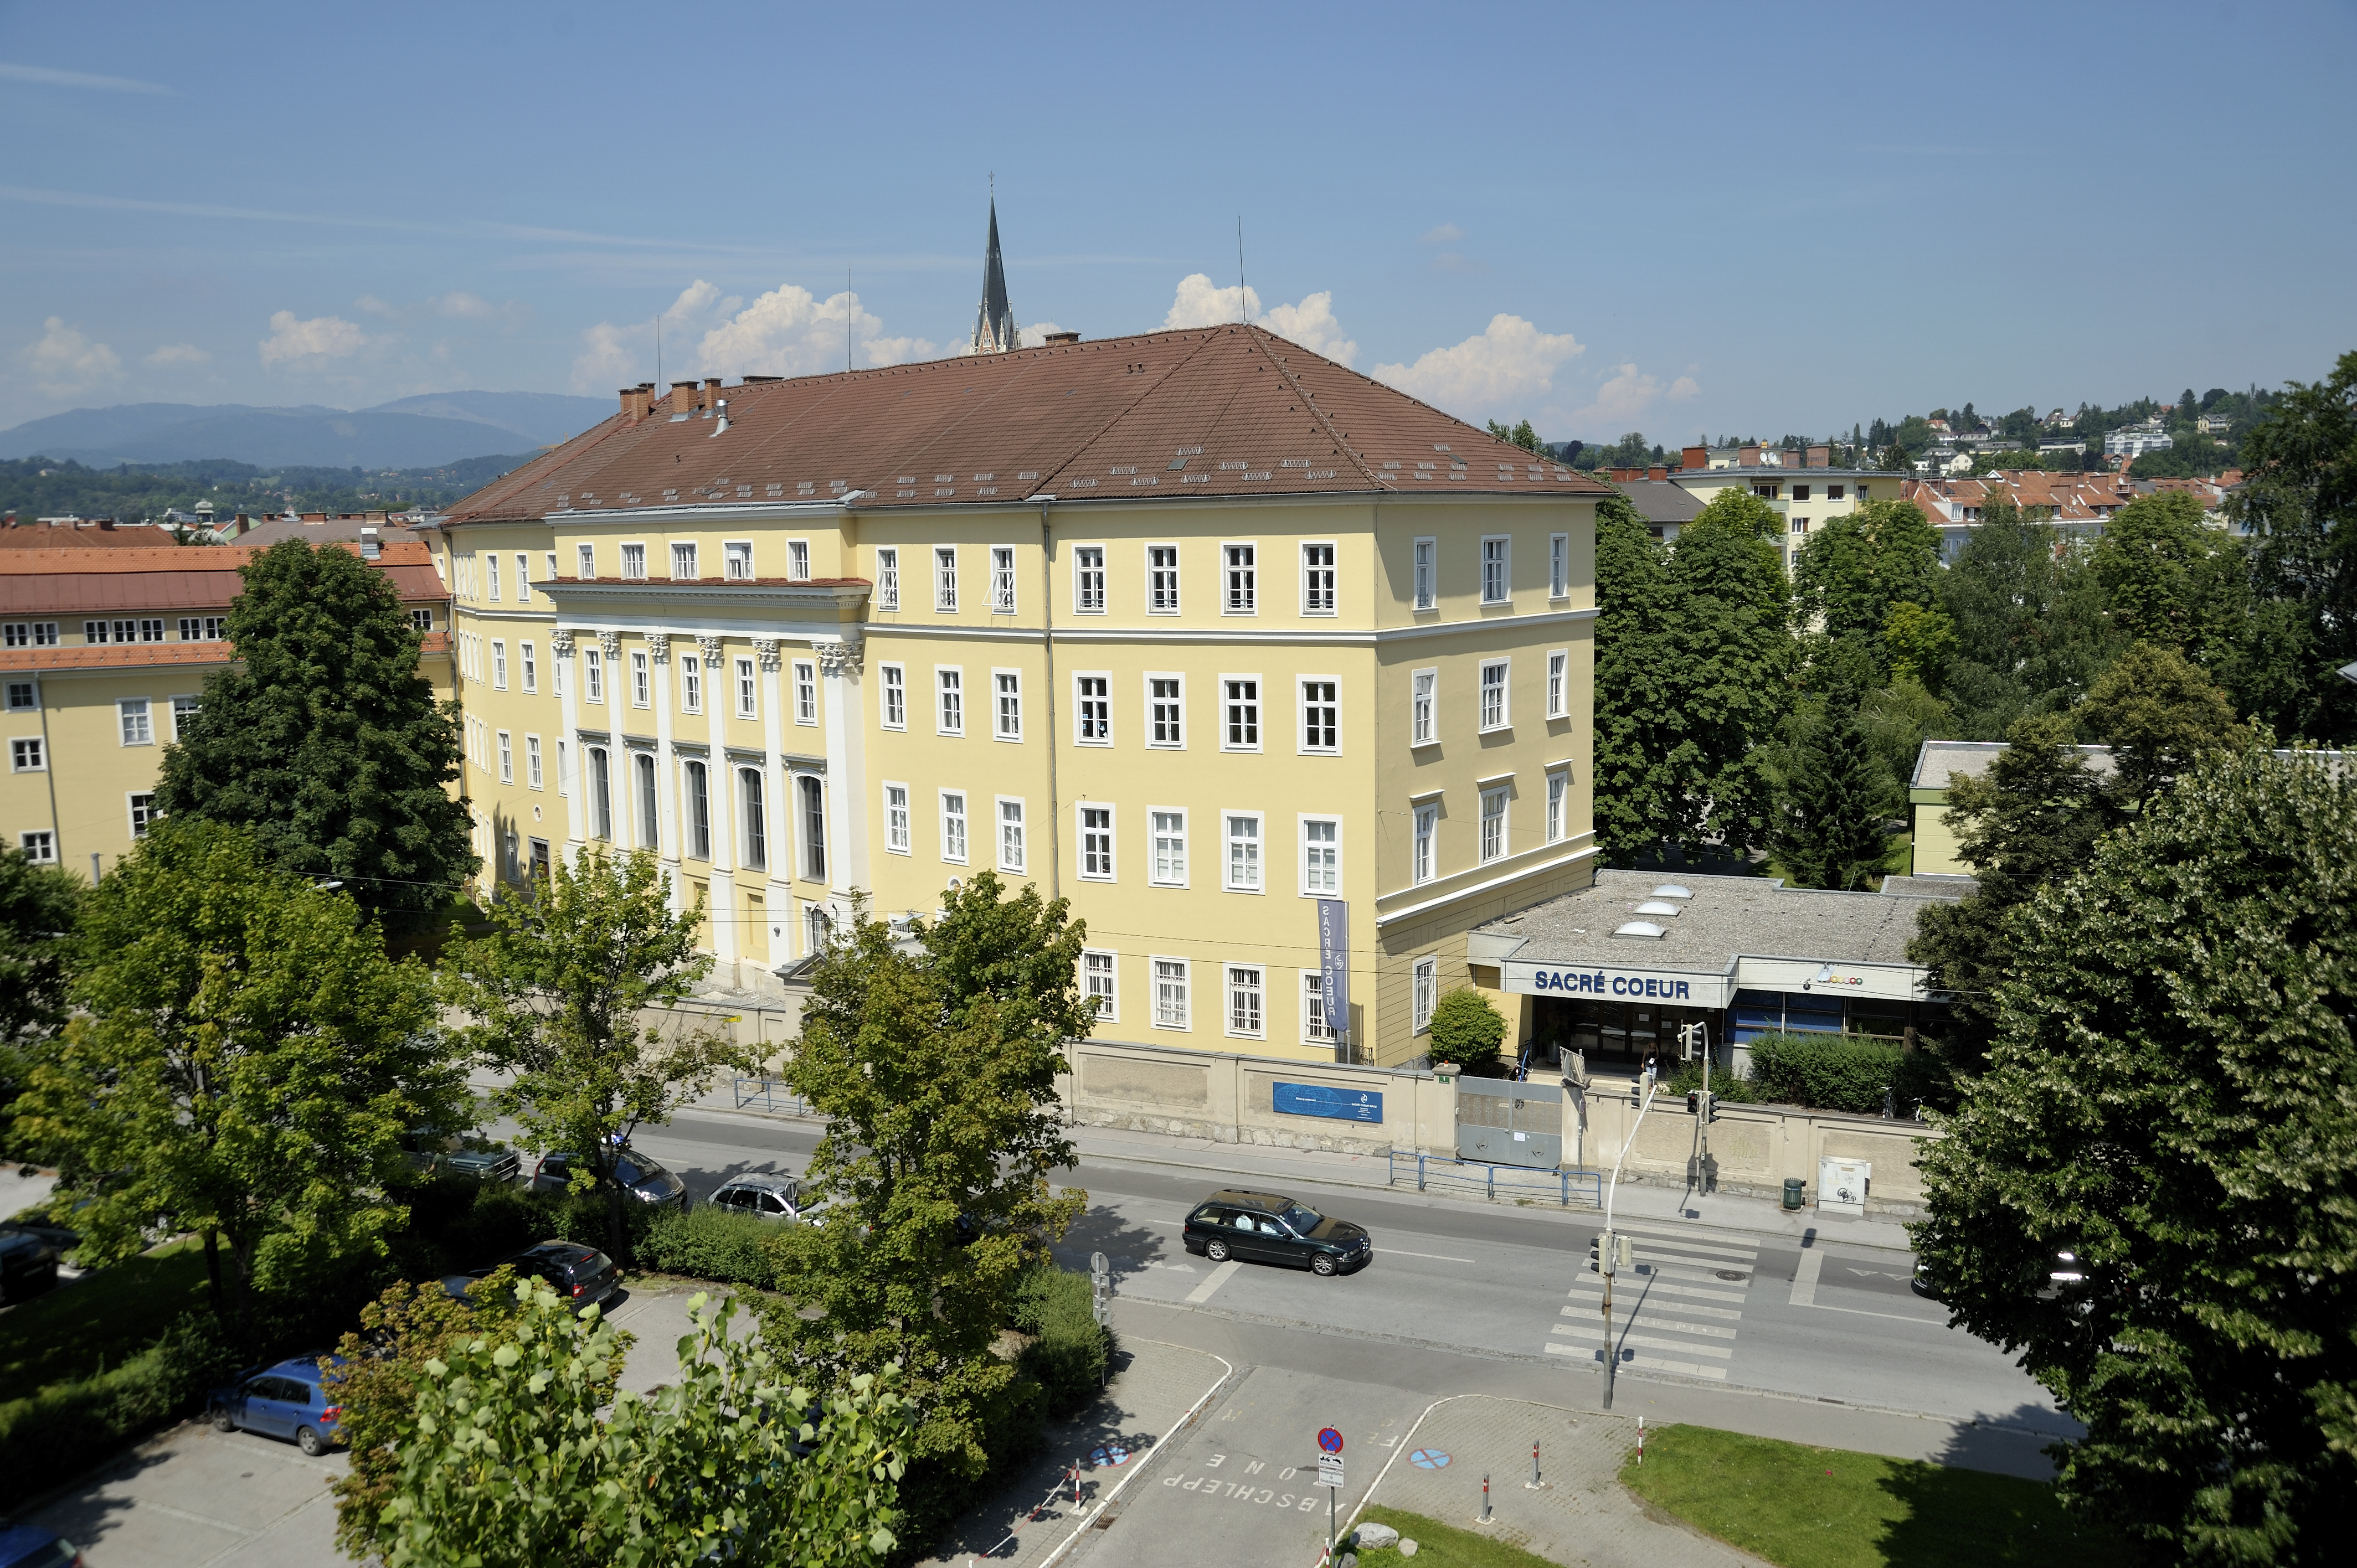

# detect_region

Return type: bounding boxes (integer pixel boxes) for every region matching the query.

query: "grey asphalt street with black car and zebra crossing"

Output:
[603,1111,2077,1433]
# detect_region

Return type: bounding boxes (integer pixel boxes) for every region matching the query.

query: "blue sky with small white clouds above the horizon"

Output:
[0,0,2357,443]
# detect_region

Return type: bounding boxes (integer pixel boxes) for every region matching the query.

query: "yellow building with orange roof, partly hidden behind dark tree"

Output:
[0,523,450,877]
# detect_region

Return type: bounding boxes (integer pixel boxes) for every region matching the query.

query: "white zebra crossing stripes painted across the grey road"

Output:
[1546,1224,1758,1382]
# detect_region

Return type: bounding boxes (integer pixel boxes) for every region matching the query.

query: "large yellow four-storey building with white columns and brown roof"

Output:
[431,326,1605,1064]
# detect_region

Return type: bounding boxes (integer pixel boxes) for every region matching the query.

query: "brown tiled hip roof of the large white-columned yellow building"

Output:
[450,326,1605,523]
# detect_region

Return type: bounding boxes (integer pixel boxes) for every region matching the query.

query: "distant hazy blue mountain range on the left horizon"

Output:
[0,391,613,469]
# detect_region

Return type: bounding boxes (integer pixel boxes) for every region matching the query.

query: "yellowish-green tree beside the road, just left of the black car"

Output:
[766,873,1096,1481]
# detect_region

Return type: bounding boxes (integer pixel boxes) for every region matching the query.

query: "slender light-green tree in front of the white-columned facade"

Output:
[441,847,749,1259]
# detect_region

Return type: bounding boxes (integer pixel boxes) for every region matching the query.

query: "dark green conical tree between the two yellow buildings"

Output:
[156,540,476,910]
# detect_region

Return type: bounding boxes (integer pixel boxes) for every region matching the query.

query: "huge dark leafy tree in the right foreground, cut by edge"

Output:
[1916,747,2357,1568]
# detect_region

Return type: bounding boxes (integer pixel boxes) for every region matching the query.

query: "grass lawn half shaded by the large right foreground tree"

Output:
[1622,1426,2133,1568]
